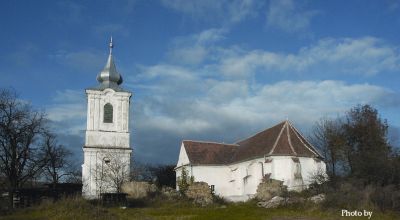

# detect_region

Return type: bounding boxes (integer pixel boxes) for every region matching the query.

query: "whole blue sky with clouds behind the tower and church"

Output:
[0,0,400,163]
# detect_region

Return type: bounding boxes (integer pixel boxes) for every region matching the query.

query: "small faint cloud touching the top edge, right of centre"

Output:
[267,0,318,32]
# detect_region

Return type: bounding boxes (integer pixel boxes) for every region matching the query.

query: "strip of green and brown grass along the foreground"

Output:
[0,199,400,220]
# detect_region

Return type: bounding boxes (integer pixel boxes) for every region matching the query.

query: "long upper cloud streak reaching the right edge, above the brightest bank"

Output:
[219,37,400,77]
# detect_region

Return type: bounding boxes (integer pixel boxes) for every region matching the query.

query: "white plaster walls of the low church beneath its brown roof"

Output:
[176,145,325,201]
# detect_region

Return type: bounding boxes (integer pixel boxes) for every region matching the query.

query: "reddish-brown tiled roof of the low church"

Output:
[183,120,322,164]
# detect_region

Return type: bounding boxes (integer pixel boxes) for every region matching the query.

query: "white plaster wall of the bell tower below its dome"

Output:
[82,89,132,198]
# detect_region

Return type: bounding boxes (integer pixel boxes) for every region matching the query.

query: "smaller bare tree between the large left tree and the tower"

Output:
[43,131,72,189]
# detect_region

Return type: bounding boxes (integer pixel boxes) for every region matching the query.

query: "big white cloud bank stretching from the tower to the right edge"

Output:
[127,34,400,141]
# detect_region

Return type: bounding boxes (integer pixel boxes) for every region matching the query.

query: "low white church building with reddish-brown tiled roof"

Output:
[175,120,326,201]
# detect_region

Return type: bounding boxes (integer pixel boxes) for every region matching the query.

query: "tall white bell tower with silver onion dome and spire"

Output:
[82,39,132,199]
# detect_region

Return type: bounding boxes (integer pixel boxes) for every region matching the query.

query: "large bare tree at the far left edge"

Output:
[0,89,46,208]
